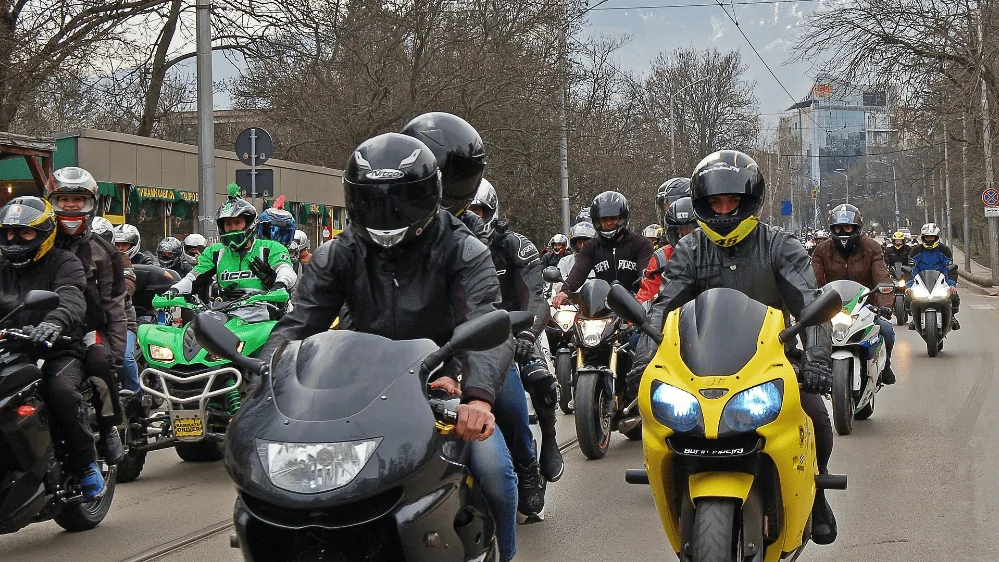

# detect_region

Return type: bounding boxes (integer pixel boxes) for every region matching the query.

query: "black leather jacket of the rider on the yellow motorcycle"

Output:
[638,224,832,365]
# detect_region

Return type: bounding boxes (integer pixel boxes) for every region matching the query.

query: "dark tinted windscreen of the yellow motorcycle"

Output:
[679,289,767,377]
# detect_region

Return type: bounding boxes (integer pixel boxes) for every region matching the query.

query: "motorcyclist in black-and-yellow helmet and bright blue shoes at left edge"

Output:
[0,197,105,500]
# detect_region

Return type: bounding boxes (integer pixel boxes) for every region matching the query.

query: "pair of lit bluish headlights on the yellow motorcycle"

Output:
[652,379,784,433]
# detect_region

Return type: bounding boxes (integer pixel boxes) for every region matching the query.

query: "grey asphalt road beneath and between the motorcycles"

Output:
[0,291,999,562]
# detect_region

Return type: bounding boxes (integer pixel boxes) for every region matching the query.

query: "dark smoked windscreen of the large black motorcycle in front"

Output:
[272,330,437,421]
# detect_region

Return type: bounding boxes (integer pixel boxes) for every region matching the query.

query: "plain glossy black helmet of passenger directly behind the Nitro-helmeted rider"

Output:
[402,112,486,216]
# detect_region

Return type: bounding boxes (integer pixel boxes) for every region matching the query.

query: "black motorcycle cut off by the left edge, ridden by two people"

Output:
[0,291,116,534]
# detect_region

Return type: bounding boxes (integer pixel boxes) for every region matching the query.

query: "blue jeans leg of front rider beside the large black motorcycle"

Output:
[468,426,520,562]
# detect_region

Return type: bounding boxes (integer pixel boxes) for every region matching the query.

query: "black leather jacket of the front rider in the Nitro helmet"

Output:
[259,210,513,404]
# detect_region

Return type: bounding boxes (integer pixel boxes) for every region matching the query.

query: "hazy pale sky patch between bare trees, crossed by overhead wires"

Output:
[584,0,819,123]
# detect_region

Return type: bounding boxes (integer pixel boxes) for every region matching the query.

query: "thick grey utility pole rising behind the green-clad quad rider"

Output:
[195,0,218,238]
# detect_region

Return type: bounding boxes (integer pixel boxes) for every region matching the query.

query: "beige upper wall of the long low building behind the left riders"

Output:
[59,130,344,207]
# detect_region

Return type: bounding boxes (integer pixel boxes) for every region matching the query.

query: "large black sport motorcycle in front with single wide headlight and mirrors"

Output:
[194,311,533,562]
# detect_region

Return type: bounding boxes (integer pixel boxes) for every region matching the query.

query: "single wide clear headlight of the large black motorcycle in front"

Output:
[257,437,382,494]
